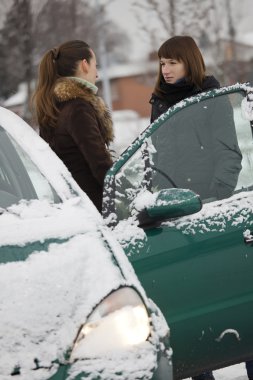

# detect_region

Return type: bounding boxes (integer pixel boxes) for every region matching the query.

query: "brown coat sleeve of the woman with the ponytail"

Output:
[68,102,113,186]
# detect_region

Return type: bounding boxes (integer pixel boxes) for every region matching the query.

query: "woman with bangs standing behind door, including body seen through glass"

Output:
[150,36,242,202]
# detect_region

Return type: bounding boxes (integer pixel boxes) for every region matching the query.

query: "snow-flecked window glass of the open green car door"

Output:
[104,91,253,220]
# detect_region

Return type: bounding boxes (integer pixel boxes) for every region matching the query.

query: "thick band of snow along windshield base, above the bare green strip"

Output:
[0,197,102,246]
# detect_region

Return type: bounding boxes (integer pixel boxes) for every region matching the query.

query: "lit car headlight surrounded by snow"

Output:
[70,287,150,360]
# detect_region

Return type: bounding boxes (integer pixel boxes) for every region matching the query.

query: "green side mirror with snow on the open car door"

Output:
[135,188,202,228]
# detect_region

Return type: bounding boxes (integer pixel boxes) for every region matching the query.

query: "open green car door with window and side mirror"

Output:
[103,84,253,379]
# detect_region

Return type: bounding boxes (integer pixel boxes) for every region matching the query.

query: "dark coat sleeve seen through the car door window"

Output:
[211,97,242,199]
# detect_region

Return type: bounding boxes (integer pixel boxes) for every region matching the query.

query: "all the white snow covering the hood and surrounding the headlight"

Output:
[0,198,168,380]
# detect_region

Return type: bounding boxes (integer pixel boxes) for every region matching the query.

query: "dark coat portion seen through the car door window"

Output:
[149,77,242,199]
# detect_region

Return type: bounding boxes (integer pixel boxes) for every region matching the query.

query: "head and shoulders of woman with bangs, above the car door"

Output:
[150,36,220,123]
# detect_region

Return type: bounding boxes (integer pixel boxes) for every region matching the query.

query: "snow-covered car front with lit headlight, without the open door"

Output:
[0,108,172,380]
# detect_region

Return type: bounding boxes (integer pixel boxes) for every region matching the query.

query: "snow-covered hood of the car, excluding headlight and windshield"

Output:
[0,199,142,379]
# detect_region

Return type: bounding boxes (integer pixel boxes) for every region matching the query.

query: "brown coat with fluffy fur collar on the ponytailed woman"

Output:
[40,78,113,212]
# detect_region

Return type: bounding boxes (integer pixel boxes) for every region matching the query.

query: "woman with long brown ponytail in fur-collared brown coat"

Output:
[33,40,113,211]
